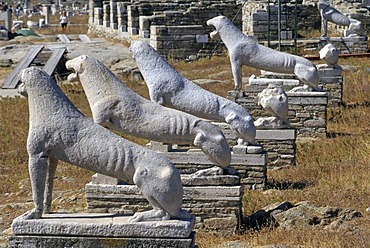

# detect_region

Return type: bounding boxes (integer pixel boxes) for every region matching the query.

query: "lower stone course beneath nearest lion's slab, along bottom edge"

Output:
[8,232,195,248]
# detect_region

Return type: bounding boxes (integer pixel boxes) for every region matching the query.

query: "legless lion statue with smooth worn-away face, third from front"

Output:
[130,41,256,144]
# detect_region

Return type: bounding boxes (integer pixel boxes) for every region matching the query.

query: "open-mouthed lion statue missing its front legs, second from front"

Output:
[66,55,231,168]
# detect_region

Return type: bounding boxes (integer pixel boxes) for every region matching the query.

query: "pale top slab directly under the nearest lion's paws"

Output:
[12,213,195,238]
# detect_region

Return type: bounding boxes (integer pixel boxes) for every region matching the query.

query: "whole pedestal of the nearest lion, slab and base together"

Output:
[9,213,194,248]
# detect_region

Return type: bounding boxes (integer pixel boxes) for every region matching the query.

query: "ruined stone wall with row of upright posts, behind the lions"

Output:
[89,0,241,58]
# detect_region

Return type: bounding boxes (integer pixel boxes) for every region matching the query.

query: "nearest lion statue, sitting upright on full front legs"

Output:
[20,67,191,222]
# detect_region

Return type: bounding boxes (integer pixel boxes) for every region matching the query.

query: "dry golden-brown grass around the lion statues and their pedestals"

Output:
[0,50,370,248]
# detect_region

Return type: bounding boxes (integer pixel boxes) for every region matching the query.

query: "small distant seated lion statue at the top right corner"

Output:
[318,0,364,37]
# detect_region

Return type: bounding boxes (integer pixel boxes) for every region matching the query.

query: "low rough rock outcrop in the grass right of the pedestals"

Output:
[245,201,362,230]
